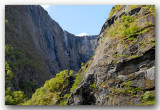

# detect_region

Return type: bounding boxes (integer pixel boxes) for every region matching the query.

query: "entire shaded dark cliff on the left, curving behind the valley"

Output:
[5,5,98,96]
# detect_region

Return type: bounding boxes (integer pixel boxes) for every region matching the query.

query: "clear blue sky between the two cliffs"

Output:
[42,5,113,35]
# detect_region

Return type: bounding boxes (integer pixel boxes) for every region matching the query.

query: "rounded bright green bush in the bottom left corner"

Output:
[5,87,27,105]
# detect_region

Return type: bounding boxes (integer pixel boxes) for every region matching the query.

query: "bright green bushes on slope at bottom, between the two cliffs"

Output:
[22,70,73,105]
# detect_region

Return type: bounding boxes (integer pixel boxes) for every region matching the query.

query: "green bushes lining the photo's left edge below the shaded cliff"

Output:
[5,44,27,105]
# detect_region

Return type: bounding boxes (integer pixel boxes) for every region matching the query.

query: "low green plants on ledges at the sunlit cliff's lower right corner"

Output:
[102,81,155,105]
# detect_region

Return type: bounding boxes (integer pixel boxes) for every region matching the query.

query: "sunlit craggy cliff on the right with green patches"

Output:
[68,5,155,105]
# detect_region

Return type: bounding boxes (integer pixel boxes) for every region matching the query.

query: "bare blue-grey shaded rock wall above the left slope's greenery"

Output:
[6,5,98,75]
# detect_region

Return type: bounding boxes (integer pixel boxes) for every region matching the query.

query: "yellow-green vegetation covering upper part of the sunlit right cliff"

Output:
[101,5,155,61]
